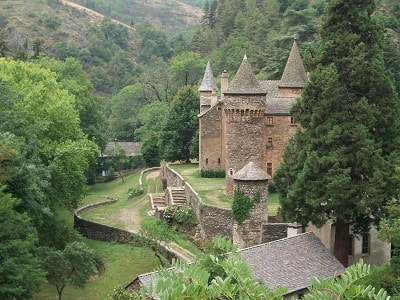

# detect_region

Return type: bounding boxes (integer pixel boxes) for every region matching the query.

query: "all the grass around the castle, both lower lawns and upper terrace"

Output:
[34,164,279,300]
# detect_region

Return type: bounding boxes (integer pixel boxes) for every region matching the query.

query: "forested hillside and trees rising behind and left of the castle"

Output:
[0,0,400,299]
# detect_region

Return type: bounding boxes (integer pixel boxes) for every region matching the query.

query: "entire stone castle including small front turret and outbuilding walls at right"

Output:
[199,41,390,264]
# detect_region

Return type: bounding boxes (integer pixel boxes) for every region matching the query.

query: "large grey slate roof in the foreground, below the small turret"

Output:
[240,232,345,294]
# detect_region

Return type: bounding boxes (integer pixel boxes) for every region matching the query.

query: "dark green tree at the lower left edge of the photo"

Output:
[0,185,45,300]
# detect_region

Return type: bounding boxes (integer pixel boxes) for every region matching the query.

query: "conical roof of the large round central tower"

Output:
[224,55,266,94]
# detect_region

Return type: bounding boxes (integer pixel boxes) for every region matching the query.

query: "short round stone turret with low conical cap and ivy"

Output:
[232,162,271,248]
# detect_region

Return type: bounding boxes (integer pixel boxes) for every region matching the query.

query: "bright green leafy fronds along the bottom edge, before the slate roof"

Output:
[112,237,390,300]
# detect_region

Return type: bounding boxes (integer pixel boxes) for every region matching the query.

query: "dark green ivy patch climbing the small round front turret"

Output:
[232,188,261,224]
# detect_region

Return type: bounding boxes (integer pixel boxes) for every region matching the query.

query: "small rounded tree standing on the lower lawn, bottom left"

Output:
[42,242,103,300]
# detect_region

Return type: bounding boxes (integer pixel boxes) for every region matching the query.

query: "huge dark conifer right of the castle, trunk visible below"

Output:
[274,0,400,266]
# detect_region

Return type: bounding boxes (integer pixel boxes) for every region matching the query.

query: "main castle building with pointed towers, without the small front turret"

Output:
[199,42,308,195]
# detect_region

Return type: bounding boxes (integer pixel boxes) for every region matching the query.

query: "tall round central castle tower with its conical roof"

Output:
[224,56,267,196]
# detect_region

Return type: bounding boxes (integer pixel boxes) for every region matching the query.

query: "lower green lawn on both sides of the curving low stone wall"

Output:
[34,171,159,300]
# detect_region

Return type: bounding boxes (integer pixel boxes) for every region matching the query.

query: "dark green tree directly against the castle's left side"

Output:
[159,86,199,162]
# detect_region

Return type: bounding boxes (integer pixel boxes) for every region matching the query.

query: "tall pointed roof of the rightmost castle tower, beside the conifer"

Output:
[279,41,308,87]
